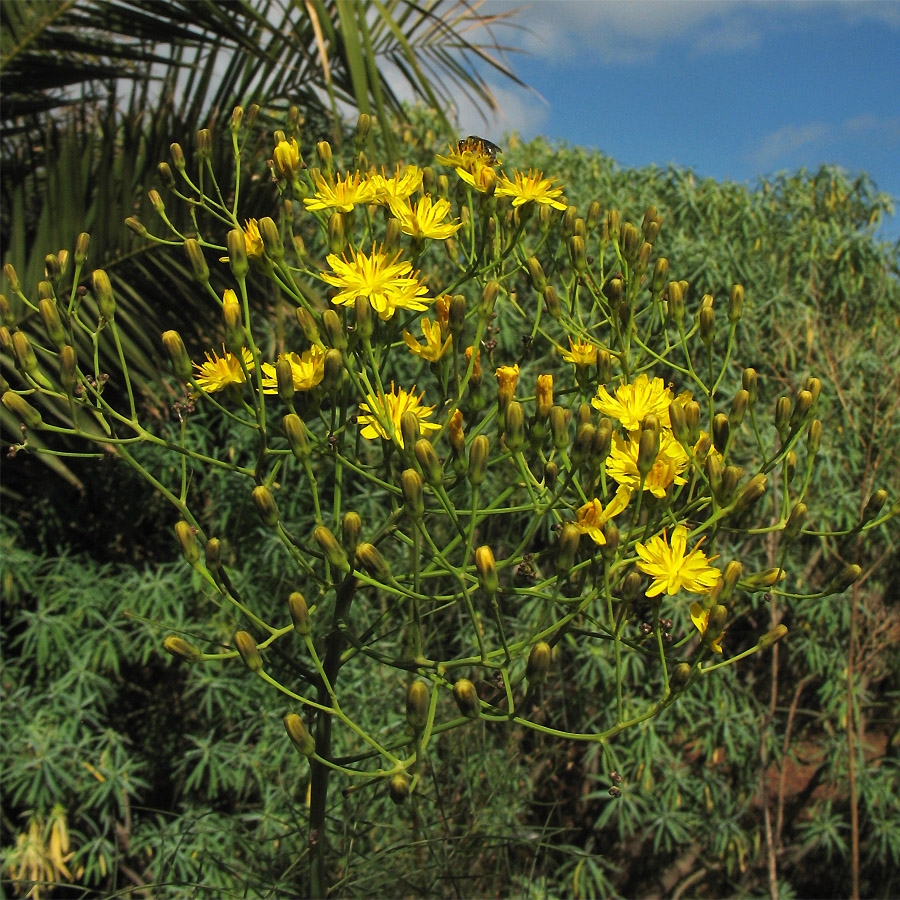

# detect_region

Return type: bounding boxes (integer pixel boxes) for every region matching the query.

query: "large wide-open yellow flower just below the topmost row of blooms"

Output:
[322,246,430,320]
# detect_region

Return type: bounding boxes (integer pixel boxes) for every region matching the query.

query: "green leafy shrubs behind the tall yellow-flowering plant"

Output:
[0,4,900,897]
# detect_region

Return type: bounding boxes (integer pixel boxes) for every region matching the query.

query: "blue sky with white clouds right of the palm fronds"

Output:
[460,0,900,238]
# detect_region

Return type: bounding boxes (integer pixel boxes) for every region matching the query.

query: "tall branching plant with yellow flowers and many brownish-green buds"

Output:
[0,108,898,896]
